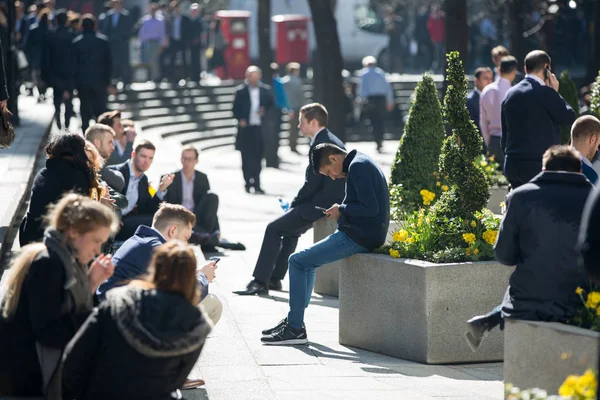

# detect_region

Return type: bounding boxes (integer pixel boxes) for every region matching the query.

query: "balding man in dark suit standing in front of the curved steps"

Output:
[233,65,274,194]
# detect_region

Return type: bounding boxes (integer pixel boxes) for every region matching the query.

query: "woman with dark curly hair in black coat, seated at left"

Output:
[19,134,97,246]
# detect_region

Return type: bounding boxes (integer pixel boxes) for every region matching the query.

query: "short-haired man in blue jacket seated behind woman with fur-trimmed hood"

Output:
[96,203,222,324]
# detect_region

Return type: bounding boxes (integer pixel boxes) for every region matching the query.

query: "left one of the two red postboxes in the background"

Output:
[215,10,251,79]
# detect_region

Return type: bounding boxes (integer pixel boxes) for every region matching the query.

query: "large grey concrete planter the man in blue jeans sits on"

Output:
[339,254,513,364]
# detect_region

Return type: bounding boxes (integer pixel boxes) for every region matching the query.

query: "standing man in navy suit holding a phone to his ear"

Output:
[501,50,576,189]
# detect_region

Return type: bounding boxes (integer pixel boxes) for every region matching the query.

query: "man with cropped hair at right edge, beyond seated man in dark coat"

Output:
[571,115,600,185]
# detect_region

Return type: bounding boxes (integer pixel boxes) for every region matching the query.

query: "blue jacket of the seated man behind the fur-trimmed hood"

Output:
[96,225,208,300]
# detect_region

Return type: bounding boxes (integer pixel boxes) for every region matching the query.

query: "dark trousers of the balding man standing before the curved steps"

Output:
[236,126,264,189]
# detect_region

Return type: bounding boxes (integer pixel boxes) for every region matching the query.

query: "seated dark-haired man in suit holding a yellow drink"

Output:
[110,140,174,240]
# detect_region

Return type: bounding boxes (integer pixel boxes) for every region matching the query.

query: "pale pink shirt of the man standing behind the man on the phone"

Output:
[479,78,512,145]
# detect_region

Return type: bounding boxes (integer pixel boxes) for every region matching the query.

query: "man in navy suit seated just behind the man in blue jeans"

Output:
[235,103,345,295]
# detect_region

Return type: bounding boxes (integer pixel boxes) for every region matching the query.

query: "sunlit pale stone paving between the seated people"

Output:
[142,138,503,400]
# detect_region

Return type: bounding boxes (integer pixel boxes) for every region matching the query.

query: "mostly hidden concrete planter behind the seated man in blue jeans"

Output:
[313,218,398,297]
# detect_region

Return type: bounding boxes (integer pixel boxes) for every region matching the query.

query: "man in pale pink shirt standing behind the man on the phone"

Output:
[479,56,519,162]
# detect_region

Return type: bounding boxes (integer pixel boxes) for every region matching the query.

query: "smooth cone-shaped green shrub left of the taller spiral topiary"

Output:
[390,74,445,210]
